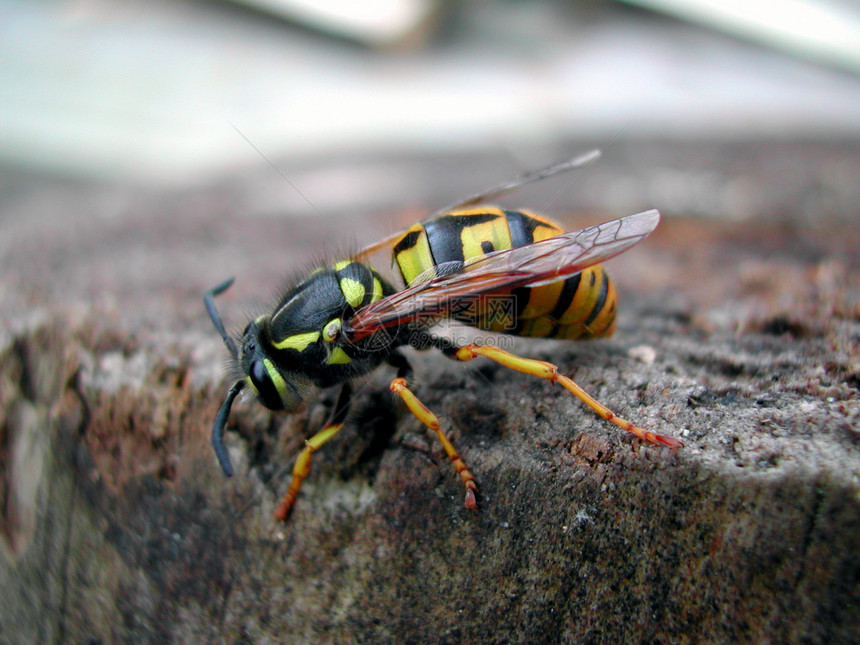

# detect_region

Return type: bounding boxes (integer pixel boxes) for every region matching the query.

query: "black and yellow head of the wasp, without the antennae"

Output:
[239,317,310,412]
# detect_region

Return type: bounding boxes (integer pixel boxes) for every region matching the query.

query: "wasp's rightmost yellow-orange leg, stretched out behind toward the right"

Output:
[454,343,684,448]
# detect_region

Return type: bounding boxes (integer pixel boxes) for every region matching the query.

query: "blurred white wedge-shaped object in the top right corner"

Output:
[624,0,860,72]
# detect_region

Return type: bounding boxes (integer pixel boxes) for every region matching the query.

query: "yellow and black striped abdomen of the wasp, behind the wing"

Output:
[393,206,616,339]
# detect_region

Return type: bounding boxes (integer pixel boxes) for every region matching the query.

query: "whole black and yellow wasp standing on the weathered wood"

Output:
[204,151,683,520]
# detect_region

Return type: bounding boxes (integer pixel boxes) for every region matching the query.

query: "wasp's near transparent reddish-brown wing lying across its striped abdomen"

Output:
[346,210,660,341]
